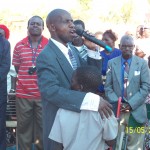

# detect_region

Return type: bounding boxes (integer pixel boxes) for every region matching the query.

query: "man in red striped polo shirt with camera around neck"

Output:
[12,16,48,150]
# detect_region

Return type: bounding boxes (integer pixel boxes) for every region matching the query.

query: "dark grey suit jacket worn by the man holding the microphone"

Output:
[36,40,101,150]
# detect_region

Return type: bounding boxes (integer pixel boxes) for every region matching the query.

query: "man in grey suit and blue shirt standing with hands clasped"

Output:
[105,35,150,150]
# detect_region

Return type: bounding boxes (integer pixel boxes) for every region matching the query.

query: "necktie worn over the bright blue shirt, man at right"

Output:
[124,61,129,98]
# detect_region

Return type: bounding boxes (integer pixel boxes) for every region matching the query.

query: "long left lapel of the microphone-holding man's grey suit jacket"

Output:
[49,40,73,82]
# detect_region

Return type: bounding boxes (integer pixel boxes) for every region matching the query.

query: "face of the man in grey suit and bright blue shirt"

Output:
[119,39,135,59]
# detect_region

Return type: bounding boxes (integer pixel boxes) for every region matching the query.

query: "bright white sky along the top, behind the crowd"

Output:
[0,0,147,22]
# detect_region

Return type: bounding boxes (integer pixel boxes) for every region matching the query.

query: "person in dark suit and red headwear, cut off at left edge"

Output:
[0,25,10,150]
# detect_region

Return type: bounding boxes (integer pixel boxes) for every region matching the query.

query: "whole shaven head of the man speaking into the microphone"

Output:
[46,9,75,46]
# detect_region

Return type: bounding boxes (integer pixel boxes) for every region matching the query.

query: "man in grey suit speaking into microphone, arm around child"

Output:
[36,9,111,150]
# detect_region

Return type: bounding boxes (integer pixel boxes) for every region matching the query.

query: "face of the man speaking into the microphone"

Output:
[48,12,77,45]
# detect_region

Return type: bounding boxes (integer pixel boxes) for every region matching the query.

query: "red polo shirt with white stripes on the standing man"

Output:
[12,36,48,99]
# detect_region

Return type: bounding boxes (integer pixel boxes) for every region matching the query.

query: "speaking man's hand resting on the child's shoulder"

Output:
[98,97,112,119]
